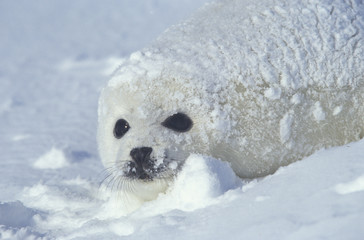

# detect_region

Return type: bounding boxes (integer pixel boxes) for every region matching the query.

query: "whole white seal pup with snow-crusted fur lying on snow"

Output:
[98,0,364,201]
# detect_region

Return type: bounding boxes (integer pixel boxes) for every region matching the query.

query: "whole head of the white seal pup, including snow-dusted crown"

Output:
[98,54,222,201]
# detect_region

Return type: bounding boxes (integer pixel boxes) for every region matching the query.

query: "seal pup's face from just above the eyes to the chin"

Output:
[98,84,205,200]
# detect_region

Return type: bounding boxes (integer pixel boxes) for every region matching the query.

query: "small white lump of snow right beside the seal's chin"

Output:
[158,155,241,211]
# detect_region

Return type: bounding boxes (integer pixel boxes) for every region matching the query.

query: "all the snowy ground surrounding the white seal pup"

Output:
[0,0,364,240]
